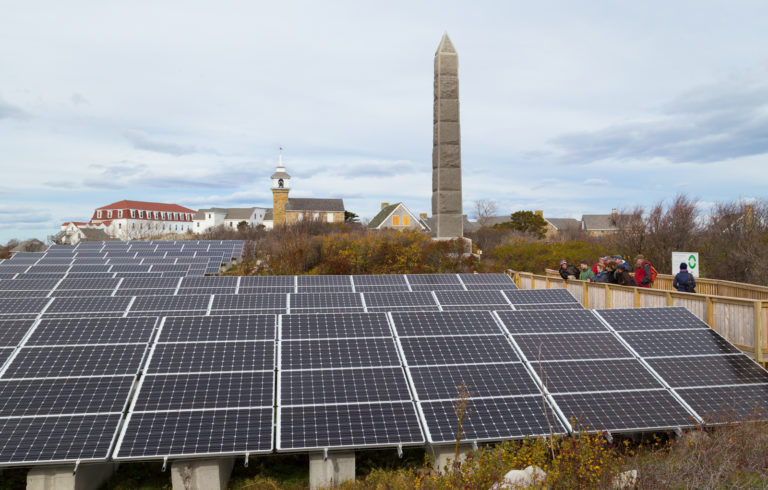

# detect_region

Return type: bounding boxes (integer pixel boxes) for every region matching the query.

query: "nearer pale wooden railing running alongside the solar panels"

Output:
[507,270,768,365]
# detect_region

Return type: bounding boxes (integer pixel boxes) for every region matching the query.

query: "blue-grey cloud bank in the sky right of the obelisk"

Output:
[551,83,768,164]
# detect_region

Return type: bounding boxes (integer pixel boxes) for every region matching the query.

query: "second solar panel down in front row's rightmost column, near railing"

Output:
[621,329,741,358]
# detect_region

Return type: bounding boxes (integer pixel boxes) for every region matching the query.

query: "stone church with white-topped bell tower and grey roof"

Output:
[264,153,344,228]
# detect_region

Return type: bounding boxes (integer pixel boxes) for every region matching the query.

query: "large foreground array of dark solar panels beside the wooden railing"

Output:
[0,256,768,465]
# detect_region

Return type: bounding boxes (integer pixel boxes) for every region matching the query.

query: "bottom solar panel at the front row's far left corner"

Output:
[0,413,122,464]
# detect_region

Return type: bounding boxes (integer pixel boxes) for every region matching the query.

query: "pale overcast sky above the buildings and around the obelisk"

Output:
[0,0,768,242]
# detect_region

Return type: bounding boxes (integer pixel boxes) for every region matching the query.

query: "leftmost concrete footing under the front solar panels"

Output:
[27,463,117,490]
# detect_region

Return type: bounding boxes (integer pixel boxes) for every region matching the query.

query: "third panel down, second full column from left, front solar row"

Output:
[133,371,275,412]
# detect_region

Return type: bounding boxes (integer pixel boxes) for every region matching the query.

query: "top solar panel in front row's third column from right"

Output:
[392,311,504,337]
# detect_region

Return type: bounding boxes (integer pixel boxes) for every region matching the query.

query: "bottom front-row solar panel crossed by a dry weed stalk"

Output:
[419,396,565,443]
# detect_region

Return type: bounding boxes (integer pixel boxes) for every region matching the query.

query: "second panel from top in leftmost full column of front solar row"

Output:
[1,344,147,379]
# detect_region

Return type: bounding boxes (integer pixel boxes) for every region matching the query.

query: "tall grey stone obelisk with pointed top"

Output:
[432,34,464,238]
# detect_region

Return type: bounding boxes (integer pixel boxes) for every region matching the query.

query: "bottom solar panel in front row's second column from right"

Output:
[553,390,694,431]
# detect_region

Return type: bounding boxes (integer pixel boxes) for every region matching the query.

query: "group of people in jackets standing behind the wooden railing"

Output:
[559,255,696,293]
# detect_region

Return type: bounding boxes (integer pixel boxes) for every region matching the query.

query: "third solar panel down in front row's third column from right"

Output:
[408,362,541,400]
